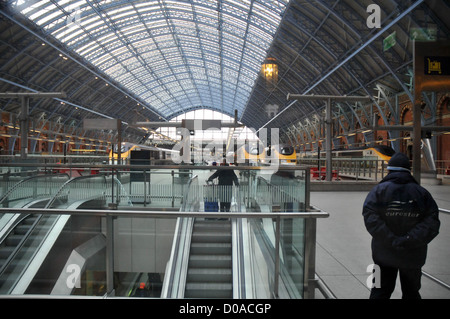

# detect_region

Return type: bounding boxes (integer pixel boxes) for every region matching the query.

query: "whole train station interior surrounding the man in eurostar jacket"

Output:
[0,0,450,302]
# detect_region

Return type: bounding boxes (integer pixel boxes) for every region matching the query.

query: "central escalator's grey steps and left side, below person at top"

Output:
[161,176,239,298]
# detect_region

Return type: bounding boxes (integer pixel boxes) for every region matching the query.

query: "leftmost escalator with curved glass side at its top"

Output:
[0,175,125,294]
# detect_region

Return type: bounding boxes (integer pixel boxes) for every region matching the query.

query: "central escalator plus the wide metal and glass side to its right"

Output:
[161,174,316,299]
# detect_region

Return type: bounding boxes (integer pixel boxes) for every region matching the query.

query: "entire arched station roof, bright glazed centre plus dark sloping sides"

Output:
[0,0,450,147]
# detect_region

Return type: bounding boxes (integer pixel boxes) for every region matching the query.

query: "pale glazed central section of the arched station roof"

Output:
[12,0,289,119]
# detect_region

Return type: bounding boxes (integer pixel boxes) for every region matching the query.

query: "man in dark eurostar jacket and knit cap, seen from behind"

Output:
[363,153,440,299]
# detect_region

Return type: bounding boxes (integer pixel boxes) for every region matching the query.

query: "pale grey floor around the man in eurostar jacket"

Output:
[311,181,450,299]
